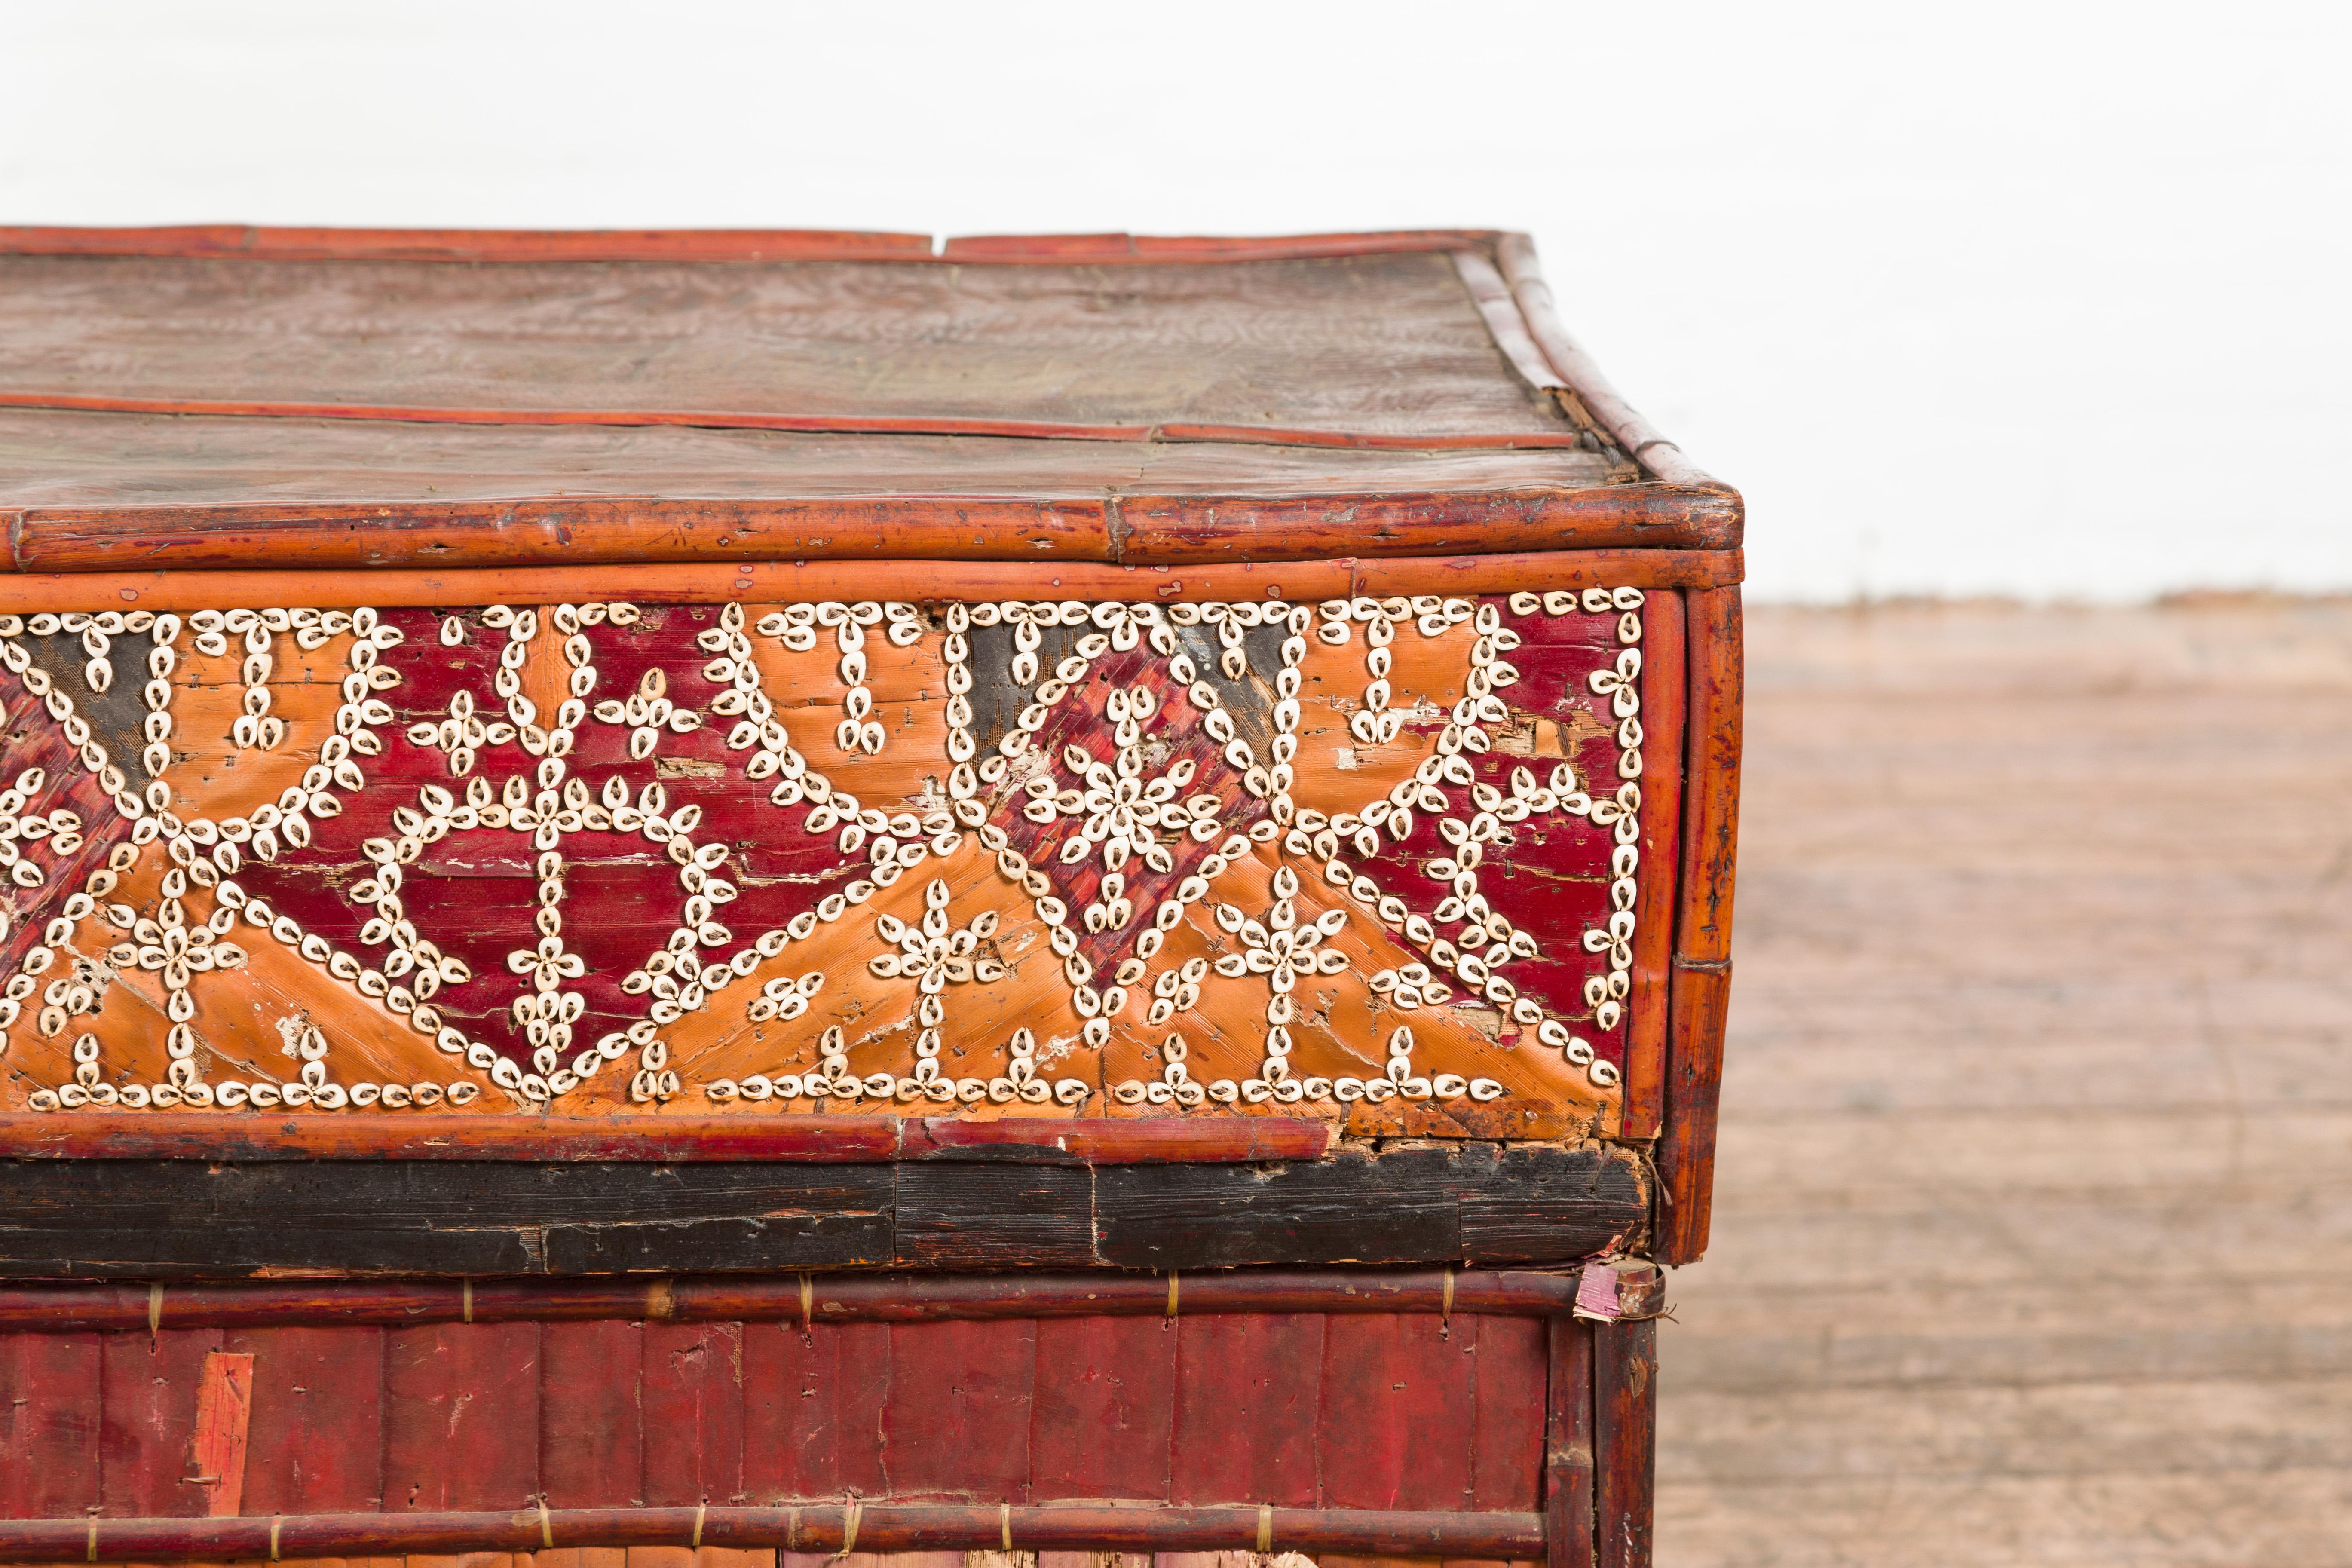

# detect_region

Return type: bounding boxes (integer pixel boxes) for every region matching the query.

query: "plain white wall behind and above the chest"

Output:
[0,0,2352,600]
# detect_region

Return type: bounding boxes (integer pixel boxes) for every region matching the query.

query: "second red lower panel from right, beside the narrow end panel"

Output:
[1317,1314,1477,1509]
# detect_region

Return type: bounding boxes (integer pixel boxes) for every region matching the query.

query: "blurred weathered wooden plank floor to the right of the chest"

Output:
[1658,602,2352,1568]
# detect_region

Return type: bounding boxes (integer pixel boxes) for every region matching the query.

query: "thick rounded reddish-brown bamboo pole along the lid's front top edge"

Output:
[0,484,1738,574]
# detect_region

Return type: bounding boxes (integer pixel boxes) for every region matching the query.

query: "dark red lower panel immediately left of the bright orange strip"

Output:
[99,1328,221,1519]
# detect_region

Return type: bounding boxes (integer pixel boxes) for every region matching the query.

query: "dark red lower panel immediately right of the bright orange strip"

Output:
[229,1328,383,1514]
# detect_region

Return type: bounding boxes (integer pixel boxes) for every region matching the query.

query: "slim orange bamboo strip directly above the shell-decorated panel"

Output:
[0,550,1745,613]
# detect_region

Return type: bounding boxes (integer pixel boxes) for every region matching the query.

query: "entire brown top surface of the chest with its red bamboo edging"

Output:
[0,230,1740,571]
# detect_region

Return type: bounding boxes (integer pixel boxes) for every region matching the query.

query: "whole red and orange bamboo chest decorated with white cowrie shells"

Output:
[0,228,1740,1568]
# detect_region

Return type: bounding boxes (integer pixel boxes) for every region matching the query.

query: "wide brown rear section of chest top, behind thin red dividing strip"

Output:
[0,251,1574,440]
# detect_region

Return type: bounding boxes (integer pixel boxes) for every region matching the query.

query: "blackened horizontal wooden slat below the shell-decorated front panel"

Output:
[0,1145,1646,1279]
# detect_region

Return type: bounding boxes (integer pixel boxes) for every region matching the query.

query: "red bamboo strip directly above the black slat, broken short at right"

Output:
[0,1112,1334,1166]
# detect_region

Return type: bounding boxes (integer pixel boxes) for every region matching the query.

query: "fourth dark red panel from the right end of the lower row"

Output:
[1030,1317,1178,1502]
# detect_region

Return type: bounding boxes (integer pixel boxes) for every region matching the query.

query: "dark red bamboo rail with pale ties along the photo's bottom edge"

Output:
[0,1502,1543,1563]
